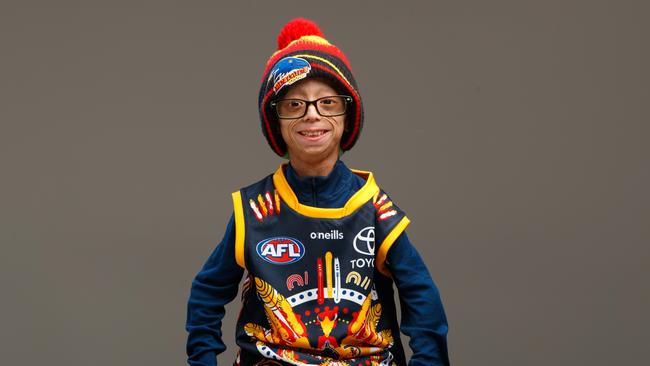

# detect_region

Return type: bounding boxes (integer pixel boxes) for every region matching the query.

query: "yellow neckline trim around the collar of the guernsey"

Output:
[273,164,379,219]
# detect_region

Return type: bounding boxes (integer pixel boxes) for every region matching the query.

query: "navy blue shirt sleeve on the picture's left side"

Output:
[185,216,244,366]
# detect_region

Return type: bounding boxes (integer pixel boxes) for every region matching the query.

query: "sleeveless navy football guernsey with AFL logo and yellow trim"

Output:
[232,165,409,366]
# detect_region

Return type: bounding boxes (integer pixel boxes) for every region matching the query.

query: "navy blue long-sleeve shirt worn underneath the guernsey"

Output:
[186,160,449,366]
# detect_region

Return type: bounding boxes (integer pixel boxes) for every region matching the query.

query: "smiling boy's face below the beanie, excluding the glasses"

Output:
[279,79,345,162]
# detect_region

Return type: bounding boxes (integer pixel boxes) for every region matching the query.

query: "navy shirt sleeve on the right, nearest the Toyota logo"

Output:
[386,232,449,366]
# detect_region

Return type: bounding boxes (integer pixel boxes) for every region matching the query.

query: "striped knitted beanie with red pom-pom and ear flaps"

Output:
[258,18,363,157]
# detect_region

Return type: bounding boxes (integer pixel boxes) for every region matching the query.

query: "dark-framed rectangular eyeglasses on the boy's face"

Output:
[271,95,352,119]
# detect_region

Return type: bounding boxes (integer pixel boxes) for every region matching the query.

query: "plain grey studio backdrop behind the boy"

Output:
[0,0,650,366]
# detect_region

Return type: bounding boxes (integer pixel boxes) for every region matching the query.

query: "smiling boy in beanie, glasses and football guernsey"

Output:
[186,19,449,366]
